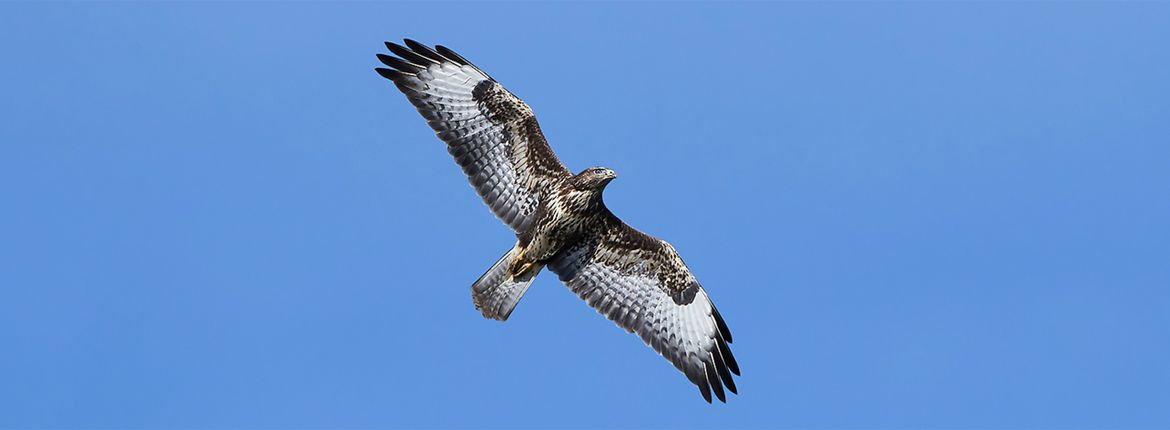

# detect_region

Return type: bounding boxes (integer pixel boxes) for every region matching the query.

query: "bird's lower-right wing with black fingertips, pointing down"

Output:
[548,215,739,402]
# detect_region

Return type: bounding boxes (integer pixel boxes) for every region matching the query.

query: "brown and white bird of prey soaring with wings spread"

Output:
[374,39,739,403]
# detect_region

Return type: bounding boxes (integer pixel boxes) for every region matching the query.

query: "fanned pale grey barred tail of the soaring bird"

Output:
[472,247,544,321]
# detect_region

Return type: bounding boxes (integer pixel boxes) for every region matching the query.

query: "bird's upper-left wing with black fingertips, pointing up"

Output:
[374,40,570,233]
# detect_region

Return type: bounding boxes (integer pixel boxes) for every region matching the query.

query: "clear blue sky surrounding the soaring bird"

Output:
[0,2,1170,429]
